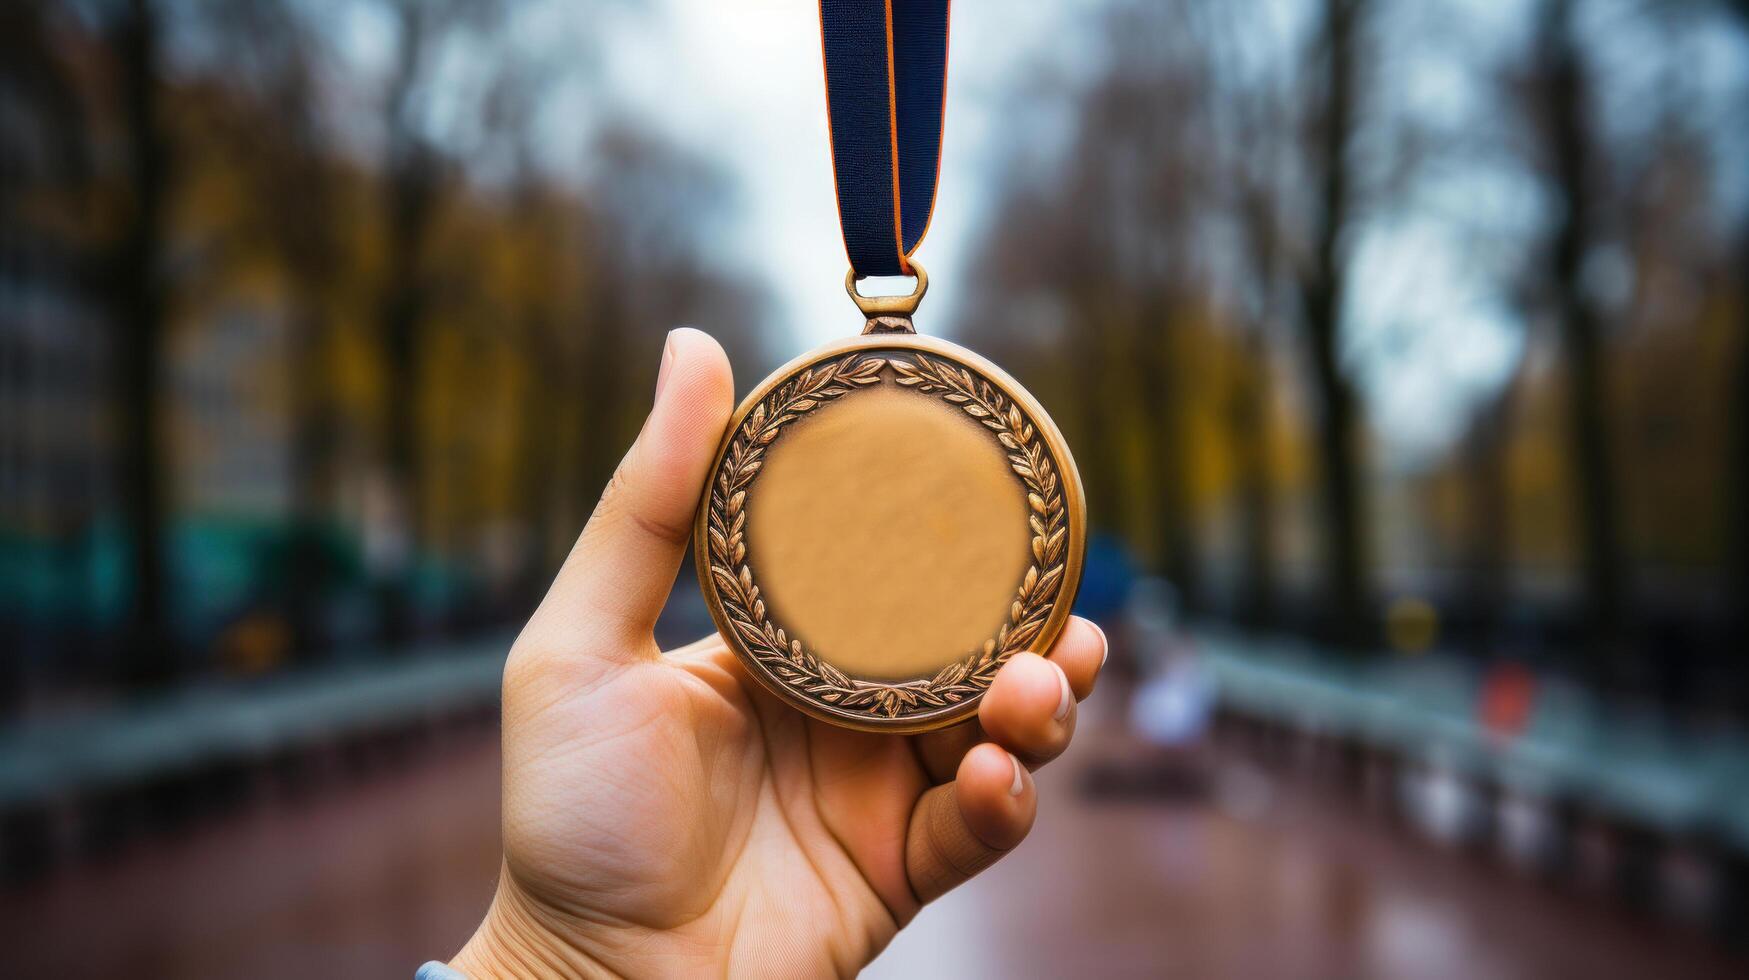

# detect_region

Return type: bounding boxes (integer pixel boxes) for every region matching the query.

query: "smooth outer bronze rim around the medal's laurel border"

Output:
[693,334,1086,733]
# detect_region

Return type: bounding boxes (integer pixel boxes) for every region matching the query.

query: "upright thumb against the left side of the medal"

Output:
[525,327,735,658]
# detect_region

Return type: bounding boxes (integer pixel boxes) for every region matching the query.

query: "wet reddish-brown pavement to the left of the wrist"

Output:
[0,726,498,978]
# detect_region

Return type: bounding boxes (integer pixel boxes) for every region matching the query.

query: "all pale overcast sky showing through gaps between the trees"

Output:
[334,0,1740,467]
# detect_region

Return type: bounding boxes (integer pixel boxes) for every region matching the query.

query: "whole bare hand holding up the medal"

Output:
[455,329,1105,977]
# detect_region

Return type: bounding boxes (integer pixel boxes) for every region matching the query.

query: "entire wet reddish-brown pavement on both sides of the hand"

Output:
[0,693,1749,978]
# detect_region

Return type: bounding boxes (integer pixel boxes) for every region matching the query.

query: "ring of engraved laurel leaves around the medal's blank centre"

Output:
[707,354,1069,719]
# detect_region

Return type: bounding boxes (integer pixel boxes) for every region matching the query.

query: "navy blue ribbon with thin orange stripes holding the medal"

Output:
[820,0,948,278]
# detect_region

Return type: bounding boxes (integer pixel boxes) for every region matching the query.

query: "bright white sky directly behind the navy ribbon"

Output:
[580,0,1088,354]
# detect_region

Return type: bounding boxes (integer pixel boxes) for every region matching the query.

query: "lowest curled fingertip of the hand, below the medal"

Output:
[904,742,1039,903]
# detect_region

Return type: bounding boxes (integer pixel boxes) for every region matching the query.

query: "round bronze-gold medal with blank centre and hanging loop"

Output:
[694,263,1086,732]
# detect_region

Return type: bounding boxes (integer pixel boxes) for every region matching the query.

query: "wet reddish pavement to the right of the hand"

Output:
[868,707,1749,978]
